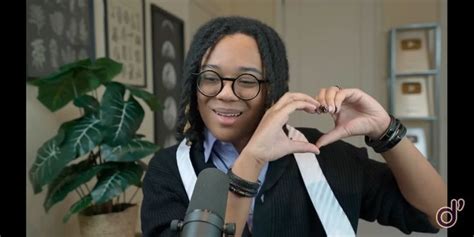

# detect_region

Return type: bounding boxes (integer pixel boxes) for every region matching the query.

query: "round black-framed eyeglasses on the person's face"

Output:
[196,70,268,100]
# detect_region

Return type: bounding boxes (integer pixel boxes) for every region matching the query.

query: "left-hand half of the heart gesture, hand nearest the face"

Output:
[242,92,321,164]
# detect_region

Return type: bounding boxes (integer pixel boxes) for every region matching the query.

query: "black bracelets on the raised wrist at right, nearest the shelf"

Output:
[365,115,407,153]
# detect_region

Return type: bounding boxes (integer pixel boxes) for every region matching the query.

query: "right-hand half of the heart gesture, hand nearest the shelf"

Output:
[316,86,390,148]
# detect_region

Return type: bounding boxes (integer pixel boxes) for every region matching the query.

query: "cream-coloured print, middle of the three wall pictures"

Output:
[104,0,146,87]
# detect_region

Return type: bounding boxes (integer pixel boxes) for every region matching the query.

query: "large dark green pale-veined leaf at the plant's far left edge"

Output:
[29,133,76,194]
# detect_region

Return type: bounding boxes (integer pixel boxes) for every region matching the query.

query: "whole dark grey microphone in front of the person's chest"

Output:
[170,168,235,237]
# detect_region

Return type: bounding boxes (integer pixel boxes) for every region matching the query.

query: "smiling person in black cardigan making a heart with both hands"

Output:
[141,17,447,236]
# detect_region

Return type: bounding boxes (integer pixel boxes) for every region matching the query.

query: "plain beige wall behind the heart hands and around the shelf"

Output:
[282,0,447,236]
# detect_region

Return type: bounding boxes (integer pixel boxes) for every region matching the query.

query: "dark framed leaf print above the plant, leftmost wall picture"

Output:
[26,0,95,80]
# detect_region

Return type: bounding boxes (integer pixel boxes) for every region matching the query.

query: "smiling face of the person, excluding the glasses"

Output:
[196,33,266,151]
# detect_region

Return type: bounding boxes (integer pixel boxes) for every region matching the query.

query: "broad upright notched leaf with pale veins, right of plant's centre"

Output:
[101,82,145,146]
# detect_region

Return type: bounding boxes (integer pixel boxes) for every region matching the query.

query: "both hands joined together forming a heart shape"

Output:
[242,87,390,164]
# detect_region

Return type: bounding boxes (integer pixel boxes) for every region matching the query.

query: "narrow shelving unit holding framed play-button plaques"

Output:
[388,23,441,171]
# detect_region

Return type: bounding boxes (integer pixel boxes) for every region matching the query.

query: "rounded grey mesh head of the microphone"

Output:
[186,168,229,219]
